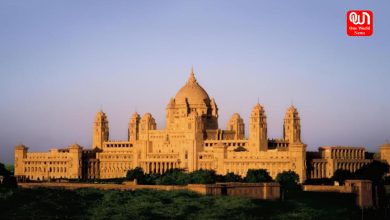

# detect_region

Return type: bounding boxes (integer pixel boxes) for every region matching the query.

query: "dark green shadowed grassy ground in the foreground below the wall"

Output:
[0,188,368,220]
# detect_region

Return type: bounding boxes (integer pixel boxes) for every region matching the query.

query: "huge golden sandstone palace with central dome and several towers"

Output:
[15,71,390,182]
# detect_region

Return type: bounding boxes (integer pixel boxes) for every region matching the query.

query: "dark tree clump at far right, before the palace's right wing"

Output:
[355,160,389,183]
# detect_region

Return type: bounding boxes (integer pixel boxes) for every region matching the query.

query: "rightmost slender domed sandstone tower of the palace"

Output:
[283,106,301,143]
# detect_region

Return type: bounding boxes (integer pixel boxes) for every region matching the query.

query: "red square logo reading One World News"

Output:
[347,10,374,37]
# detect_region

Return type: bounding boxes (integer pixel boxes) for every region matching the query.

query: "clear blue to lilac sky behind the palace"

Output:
[0,0,390,163]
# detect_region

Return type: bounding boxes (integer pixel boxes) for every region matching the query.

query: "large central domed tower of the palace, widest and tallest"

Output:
[166,70,218,129]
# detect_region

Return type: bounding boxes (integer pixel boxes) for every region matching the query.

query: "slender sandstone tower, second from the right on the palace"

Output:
[249,103,268,151]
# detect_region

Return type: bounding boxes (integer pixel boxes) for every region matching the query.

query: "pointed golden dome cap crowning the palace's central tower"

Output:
[175,71,210,105]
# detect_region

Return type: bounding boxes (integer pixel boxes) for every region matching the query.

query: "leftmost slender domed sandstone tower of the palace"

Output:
[92,111,109,149]
